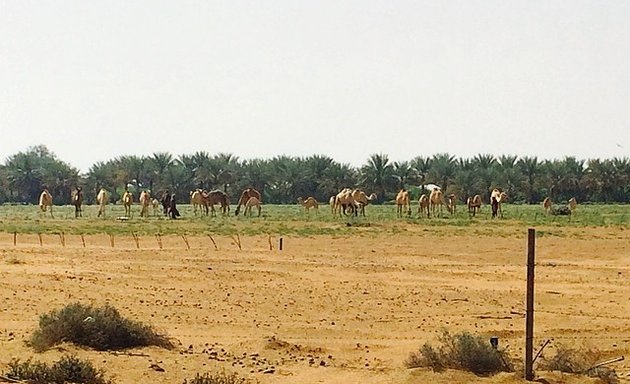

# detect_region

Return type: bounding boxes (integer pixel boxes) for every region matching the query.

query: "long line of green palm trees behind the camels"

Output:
[0,145,630,204]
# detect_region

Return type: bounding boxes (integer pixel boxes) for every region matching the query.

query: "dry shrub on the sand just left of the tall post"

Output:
[405,331,513,375]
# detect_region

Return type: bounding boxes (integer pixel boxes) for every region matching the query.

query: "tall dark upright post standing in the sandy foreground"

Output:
[525,228,536,381]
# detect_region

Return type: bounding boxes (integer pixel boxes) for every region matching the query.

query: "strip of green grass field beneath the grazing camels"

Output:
[0,204,630,236]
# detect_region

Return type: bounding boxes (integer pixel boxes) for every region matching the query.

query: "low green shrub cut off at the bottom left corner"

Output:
[4,355,111,384]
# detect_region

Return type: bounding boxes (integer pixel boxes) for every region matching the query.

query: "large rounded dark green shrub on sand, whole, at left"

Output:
[30,303,173,351]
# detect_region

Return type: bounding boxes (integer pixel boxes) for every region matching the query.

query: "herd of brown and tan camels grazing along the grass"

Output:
[33,187,577,218]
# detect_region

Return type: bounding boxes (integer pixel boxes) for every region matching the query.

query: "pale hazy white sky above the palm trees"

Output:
[0,0,630,172]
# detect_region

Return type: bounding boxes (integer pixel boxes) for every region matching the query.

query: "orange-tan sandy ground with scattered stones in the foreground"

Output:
[0,226,630,383]
